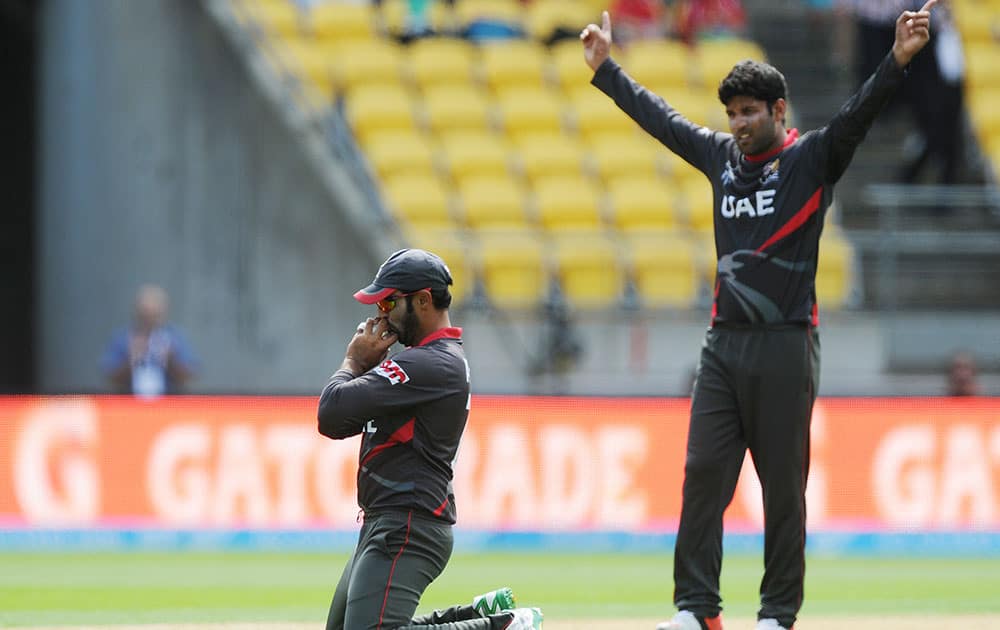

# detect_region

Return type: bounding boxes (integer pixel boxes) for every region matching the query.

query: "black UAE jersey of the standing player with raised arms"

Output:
[592,54,904,325]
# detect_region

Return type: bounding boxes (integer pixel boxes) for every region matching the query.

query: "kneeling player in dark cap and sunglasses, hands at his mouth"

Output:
[318,249,542,630]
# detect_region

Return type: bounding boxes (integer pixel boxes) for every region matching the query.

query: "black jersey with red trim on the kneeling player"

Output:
[318,328,470,523]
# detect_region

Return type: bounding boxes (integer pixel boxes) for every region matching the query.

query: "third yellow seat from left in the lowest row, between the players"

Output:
[552,230,625,309]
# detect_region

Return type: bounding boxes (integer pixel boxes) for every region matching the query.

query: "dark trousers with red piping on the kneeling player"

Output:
[326,512,511,630]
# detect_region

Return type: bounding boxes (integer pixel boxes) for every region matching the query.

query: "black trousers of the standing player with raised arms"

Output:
[674,325,819,628]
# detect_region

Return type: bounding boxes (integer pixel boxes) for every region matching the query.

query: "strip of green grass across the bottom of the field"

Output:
[0,552,1000,626]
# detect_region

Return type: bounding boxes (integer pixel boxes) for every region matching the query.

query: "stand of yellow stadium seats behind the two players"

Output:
[234,0,860,309]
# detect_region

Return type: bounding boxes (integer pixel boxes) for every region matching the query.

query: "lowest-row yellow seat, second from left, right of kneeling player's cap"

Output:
[476,228,549,309]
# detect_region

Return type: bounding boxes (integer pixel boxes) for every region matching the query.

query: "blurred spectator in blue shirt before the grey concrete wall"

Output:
[101,284,196,398]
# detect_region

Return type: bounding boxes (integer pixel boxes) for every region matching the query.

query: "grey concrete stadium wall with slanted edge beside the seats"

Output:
[37,0,384,393]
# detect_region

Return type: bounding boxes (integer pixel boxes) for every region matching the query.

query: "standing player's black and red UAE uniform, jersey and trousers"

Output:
[592,55,904,628]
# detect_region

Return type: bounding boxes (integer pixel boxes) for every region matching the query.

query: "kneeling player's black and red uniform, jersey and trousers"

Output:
[318,328,496,630]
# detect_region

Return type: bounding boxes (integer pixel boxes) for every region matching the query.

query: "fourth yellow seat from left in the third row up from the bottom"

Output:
[587,133,675,185]
